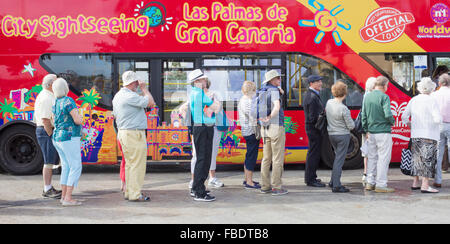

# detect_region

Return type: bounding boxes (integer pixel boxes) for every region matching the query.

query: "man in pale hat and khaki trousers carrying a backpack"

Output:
[257,70,288,196]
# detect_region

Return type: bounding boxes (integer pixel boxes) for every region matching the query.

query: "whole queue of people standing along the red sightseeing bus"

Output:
[35,69,450,206]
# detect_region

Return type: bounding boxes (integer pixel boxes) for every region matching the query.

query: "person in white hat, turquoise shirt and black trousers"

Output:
[188,69,219,202]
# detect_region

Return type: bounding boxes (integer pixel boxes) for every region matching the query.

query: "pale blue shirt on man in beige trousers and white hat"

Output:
[113,87,148,130]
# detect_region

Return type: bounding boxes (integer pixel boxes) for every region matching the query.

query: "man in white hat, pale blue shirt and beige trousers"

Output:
[113,71,155,202]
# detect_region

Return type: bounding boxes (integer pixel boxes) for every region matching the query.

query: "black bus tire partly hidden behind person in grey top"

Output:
[321,132,364,169]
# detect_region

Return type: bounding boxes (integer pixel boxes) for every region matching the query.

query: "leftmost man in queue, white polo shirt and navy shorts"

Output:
[34,74,61,199]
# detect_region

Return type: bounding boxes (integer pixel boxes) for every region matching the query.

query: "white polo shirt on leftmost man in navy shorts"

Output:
[34,89,55,126]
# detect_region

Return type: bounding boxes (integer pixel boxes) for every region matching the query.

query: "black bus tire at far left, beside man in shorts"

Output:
[0,124,43,175]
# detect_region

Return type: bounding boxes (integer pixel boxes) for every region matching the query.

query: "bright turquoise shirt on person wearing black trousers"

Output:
[189,87,216,126]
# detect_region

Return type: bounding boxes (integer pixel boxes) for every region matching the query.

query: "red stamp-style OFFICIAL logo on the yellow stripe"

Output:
[359,7,415,43]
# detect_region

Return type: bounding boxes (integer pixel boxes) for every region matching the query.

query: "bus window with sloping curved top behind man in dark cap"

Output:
[286,54,364,108]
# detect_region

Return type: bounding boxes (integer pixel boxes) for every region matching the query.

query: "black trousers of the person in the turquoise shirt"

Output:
[192,126,214,197]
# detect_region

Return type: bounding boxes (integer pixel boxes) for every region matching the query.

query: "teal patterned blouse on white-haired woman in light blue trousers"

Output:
[52,96,81,141]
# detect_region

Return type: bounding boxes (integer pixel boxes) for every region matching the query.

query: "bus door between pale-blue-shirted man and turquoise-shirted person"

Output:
[115,57,195,161]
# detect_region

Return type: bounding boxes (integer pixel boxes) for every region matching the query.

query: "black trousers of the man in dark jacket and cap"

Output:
[305,125,322,184]
